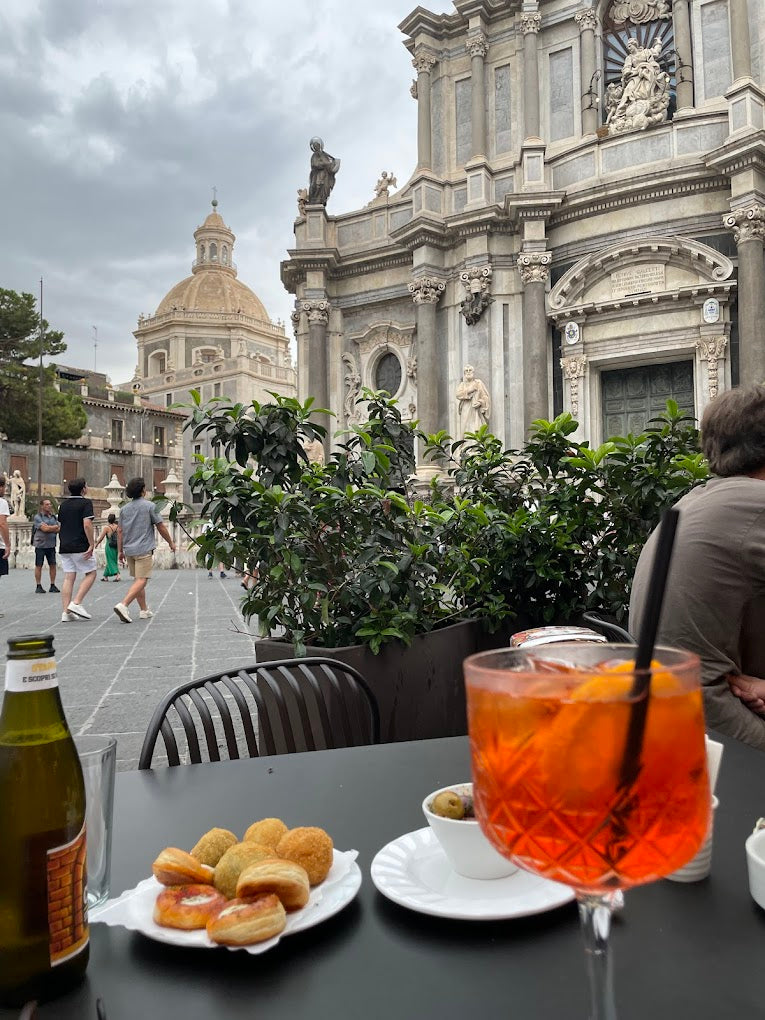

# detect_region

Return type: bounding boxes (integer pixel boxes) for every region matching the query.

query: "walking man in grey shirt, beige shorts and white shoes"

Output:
[114,478,175,623]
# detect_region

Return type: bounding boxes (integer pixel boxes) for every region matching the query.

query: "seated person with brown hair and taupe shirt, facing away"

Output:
[629,385,765,751]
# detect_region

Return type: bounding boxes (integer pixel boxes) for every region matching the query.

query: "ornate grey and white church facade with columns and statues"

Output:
[282,0,765,456]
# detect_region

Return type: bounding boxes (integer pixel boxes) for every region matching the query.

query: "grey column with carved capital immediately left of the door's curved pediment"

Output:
[518,252,553,429]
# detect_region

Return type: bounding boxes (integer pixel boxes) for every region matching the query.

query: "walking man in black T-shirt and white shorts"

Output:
[58,478,97,623]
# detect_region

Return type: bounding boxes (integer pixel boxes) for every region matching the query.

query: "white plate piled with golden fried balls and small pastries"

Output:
[90,818,361,954]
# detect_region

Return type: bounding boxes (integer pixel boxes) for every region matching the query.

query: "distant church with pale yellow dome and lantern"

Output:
[128,199,297,502]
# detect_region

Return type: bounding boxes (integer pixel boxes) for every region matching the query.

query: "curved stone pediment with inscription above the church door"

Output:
[548,237,733,317]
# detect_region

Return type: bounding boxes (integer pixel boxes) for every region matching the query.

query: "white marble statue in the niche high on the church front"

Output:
[606,38,670,135]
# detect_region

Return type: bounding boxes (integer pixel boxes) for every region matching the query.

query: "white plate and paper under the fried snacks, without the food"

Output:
[90,850,361,954]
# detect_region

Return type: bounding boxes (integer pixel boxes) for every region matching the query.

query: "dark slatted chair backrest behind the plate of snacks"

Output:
[138,657,379,769]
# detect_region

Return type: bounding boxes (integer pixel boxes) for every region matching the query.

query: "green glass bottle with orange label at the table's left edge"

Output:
[0,636,89,1006]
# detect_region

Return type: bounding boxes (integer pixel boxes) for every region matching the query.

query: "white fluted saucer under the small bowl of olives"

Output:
[371,827,574,921]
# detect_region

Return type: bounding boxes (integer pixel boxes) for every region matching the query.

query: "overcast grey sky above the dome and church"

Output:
[0,0,453,383]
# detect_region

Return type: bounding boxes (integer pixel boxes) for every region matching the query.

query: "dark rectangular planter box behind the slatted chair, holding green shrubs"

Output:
[256,621,503,743]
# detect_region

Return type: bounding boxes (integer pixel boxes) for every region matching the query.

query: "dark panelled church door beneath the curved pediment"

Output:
[601,361,695,439]
